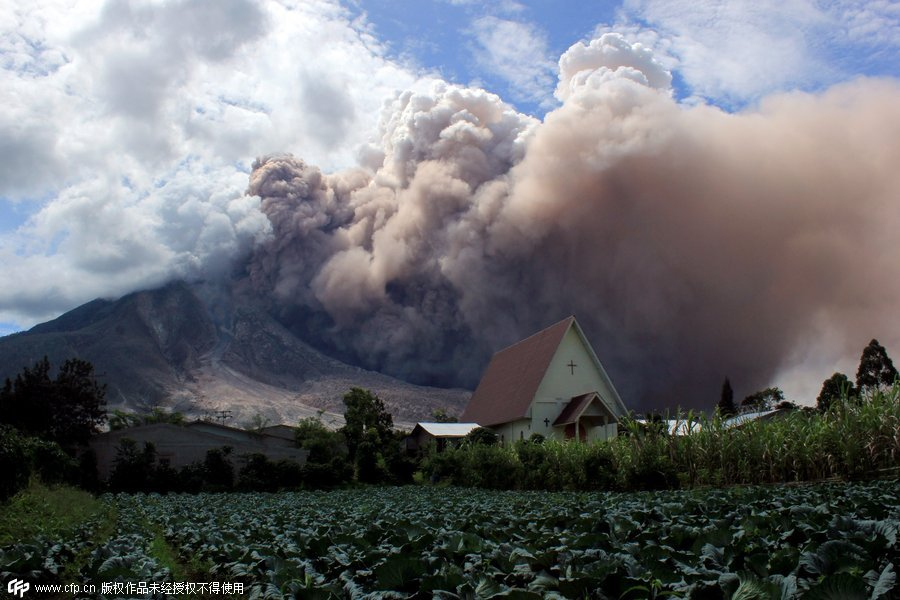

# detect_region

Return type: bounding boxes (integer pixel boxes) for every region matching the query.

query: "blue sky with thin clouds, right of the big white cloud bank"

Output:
[348,0,900,116]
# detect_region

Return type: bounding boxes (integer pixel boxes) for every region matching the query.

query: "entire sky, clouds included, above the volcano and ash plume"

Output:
[0,0,900,334]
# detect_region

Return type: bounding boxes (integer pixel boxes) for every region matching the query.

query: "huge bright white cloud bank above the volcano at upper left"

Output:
[0,0,426,325]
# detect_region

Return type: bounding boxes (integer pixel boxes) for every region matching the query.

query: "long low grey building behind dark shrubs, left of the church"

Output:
[89,421,308,480]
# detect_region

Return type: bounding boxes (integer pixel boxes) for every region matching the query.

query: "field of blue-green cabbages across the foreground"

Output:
[0,481,900,600]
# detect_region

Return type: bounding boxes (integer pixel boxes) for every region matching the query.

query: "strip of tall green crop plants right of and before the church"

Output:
[421,385,900,491]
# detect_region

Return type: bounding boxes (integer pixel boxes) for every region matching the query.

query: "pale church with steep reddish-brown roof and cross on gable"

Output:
[460,317,627,441]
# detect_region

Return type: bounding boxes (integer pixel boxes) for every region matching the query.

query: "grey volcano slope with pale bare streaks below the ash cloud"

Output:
[0,282,470,427]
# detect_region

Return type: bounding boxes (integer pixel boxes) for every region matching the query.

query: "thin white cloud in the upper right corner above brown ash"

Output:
[614,0,900,107]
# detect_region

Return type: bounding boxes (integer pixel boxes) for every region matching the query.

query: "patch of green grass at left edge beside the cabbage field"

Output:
[0,480,107,546]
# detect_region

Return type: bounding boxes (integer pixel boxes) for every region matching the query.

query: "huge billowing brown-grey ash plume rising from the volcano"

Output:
[241,34,900,408]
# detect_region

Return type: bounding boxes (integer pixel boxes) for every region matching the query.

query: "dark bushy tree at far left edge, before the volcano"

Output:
[0,356,106,446]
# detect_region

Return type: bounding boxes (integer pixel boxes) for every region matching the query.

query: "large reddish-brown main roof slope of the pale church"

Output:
[461,317,575,426]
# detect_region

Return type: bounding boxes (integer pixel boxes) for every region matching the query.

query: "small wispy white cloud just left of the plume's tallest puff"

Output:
[473,16,555,106]
